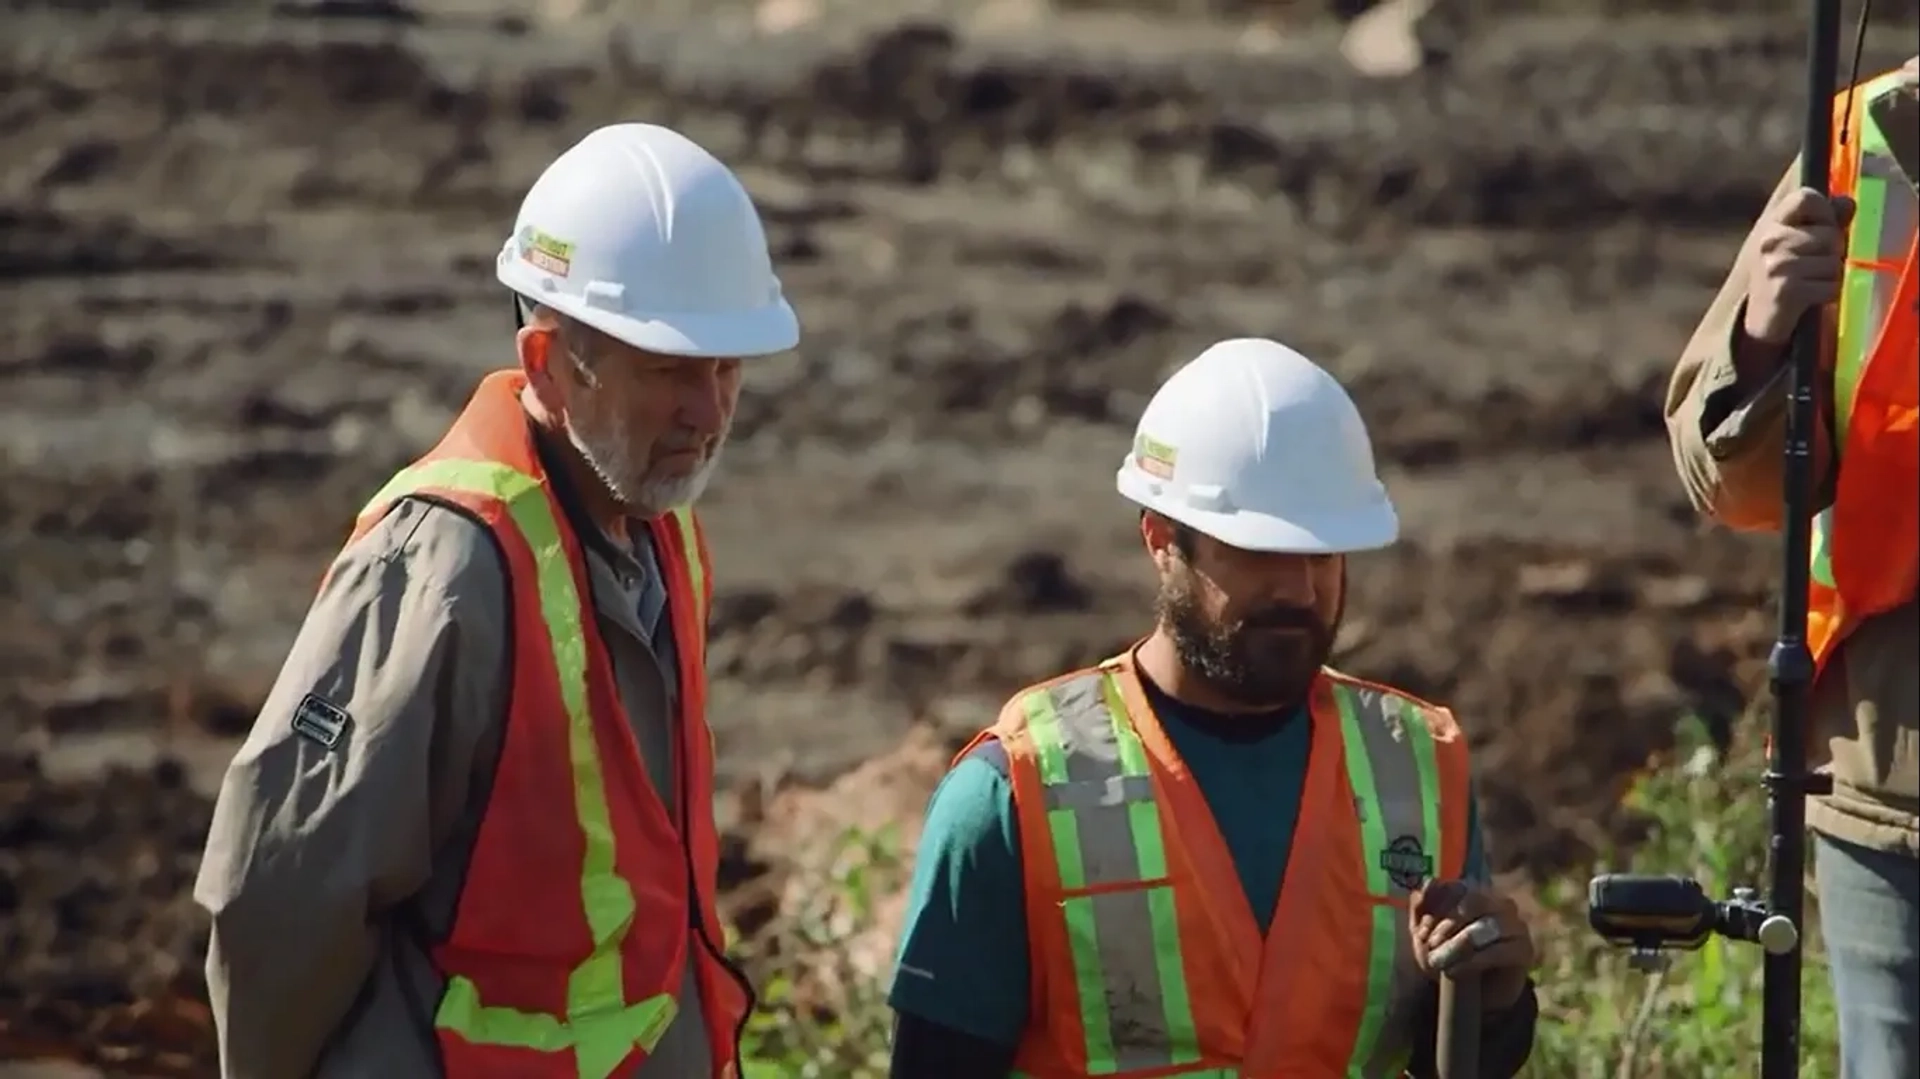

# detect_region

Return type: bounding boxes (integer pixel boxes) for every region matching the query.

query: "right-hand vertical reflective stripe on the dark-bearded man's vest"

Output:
[1332,682,1440,1079]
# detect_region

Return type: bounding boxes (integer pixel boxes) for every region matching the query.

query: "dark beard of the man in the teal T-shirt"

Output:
[1154,570,1338,708]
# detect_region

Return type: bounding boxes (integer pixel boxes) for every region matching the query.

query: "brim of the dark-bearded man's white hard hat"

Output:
[1117,468,1400,555]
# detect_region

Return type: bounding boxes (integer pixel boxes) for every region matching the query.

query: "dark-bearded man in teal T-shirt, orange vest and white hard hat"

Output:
[891,340,1538,1079]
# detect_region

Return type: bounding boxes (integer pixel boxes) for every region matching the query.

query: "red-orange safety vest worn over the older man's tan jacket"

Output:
[337,371,747,1079]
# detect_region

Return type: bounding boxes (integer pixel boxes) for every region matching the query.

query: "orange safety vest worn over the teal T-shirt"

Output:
[956,651,1469,1079]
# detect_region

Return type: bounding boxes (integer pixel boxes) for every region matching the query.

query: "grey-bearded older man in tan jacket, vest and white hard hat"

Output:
[194,123,799,1079]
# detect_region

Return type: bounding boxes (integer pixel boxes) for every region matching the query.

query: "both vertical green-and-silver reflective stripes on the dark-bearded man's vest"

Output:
[1020,670,1440,1079]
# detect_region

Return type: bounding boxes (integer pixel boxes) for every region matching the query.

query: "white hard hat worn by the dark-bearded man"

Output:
[1119,338,1400,555]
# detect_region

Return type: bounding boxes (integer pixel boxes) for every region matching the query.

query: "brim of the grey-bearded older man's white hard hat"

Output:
[495,255,801,359]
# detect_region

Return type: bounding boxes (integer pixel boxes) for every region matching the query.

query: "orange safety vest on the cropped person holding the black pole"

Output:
[1807,71,1920,664]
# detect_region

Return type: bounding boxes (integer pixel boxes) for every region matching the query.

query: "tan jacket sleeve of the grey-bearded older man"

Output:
[194,501,509,1079]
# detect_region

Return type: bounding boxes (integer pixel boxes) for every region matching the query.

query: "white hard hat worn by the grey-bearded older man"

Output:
[495,123,801,357]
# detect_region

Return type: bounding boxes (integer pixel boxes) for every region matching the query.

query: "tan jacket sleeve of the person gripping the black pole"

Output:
[1667,159,1828,532]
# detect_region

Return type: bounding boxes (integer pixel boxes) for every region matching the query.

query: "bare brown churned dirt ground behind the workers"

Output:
[0,0,1912,1075]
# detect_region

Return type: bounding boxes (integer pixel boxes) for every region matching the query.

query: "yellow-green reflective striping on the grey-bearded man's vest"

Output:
[363,461,683,1079]
